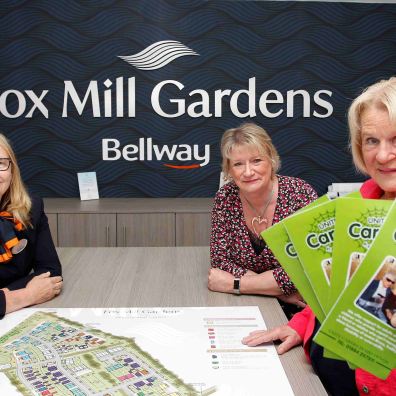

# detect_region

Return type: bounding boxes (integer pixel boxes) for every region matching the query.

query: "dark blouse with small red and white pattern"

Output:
[210,175,317,295]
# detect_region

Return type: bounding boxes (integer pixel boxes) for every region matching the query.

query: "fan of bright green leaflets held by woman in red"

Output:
[262,194,396,378]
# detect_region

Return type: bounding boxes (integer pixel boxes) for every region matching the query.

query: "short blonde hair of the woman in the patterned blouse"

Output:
[221,123,280,177]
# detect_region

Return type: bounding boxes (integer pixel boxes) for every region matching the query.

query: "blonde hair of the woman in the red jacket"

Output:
[348,77,396,173]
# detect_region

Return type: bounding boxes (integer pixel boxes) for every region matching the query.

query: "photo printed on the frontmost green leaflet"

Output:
[355,256,396,328]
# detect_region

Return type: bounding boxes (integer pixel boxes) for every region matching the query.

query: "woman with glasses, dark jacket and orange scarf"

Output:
[0,134,62,318]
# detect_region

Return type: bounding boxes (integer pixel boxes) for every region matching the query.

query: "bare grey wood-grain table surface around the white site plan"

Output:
[41,247,327,396]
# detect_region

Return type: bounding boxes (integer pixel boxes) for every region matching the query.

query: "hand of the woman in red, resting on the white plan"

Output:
[242,325,302,355]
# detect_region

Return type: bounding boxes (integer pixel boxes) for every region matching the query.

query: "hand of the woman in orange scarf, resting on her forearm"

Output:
[26,272,63,305]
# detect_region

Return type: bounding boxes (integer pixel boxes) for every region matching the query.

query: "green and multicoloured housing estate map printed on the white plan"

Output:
[0,312,197,396]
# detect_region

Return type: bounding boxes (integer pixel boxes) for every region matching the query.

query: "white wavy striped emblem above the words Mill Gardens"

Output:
[118,40,199,70]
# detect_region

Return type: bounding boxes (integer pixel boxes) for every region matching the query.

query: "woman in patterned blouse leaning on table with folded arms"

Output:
[208,123,317,310]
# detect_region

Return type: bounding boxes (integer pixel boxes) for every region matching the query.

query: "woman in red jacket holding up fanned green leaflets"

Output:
[242,77,396,396]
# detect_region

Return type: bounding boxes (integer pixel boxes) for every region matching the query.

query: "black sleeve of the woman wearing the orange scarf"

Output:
[7,198,62,290]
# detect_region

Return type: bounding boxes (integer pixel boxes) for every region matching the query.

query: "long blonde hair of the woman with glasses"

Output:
[0,133,32,227]
